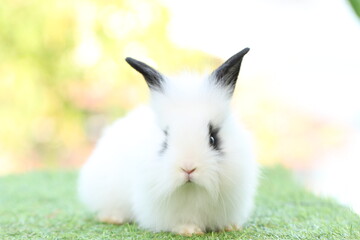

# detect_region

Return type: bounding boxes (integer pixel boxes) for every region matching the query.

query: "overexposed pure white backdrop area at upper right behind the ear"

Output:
[163,0,360,213]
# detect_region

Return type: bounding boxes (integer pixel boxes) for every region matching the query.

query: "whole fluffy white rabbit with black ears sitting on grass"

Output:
[78,48,258,235]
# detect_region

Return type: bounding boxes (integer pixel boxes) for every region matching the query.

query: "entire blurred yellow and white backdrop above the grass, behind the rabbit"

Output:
[0,0,360,212]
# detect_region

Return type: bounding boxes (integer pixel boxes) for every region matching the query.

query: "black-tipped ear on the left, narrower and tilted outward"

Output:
[125,57,164,91]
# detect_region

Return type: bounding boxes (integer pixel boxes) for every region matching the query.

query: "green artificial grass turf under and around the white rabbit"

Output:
[0,168,360,240]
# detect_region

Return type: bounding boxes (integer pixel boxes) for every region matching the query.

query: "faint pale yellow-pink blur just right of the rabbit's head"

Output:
[235,78,346,169]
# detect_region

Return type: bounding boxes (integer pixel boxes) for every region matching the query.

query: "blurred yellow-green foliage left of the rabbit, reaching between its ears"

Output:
[0,0,219,173]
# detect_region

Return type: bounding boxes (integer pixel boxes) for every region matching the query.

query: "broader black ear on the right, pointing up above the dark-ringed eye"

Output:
[211,48,250,95]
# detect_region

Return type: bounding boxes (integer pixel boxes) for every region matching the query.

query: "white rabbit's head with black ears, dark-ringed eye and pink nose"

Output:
[126,48,249,200]
